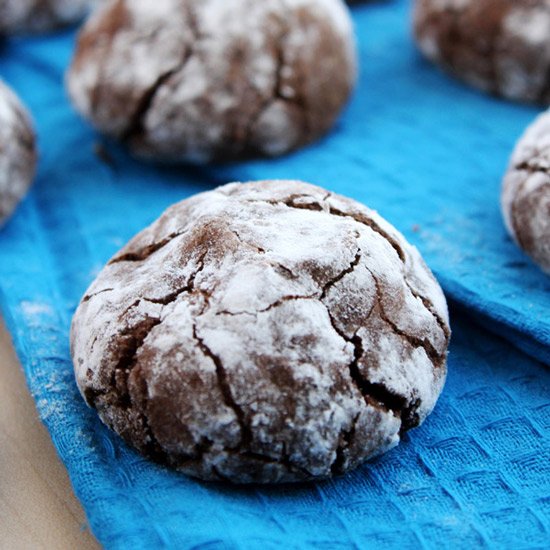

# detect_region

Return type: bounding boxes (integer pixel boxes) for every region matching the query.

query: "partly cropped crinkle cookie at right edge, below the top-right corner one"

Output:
[502,111,550,273]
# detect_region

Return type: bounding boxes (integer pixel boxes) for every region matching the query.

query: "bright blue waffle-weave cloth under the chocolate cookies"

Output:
[0,1,550,549]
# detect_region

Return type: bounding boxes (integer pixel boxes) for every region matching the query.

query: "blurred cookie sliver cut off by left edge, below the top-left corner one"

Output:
[0,81,36,225]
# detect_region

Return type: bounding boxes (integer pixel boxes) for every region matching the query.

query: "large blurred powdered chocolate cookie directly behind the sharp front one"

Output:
[68,0,356,162]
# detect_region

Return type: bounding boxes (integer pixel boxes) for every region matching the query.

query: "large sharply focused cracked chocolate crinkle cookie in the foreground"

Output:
[71,181,449,483]
